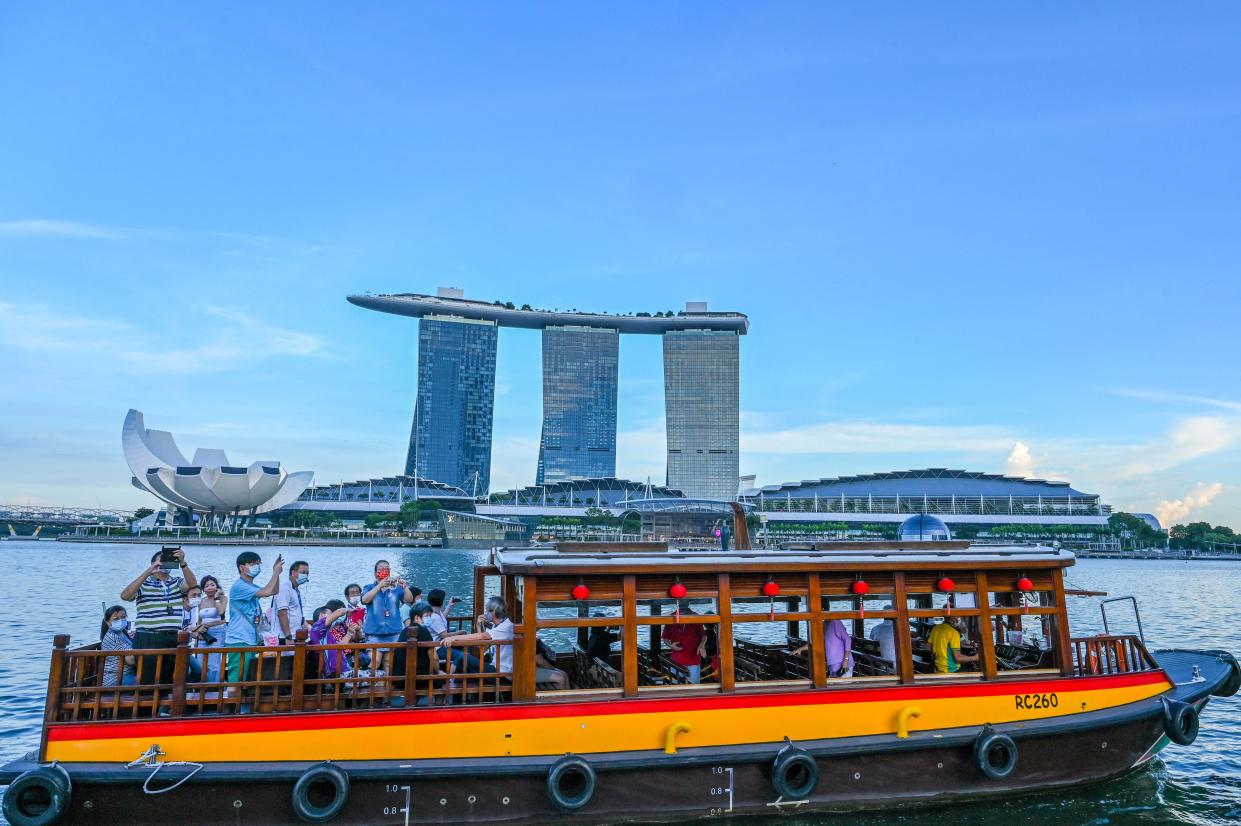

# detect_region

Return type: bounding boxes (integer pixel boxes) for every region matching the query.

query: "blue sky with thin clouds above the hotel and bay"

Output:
[0,2,1241,527]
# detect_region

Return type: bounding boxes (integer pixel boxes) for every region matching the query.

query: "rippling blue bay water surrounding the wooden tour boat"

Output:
[0,542,1241,826]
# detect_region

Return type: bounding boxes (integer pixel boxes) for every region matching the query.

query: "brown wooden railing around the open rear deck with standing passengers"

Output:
[46,630,522,723]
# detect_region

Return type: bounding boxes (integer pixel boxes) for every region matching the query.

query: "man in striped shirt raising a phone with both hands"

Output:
[120,548,199,683]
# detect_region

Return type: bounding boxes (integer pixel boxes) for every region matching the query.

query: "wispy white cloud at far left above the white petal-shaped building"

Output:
[0,301,328,372]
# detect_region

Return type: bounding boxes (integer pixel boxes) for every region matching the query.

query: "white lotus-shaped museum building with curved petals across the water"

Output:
[120,411,314,515]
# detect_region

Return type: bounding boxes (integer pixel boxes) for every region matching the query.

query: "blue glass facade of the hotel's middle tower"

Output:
[535,326,621,485]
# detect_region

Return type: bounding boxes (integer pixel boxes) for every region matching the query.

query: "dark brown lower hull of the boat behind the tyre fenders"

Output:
[0,716,1181,826]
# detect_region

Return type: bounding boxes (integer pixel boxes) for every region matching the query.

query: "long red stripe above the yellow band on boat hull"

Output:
[47,671,1168,742]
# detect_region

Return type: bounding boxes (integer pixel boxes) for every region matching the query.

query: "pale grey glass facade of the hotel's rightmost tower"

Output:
[664,330,741,500]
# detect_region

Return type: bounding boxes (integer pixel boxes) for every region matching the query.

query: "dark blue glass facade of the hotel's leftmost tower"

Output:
[405,315,498,495]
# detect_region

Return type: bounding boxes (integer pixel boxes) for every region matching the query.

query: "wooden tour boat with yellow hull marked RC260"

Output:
[0,508,1241,826]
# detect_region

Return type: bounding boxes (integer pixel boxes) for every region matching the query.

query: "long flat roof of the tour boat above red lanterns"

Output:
[491,542,1075,575]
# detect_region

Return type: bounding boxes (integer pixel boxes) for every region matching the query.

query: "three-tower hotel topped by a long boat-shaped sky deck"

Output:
[349,288,750,499]
